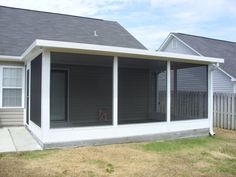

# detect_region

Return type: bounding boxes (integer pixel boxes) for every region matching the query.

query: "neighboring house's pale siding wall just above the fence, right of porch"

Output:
[213,69,234,93]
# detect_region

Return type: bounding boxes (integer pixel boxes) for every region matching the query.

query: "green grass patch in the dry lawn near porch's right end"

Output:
[143,137,217,153]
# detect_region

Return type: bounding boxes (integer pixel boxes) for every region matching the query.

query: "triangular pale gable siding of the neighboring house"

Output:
[162,38,197,55]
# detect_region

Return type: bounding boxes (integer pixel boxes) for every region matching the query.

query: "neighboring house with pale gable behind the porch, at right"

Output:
[158,33,236,93]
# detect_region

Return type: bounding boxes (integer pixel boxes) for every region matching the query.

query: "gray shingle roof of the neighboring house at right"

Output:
[173,33,236,78]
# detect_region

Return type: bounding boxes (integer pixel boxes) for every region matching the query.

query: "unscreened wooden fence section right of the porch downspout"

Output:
[213,93,236,130]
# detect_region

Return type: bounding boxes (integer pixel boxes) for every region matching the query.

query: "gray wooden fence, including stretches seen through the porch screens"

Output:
[159,91,236,130]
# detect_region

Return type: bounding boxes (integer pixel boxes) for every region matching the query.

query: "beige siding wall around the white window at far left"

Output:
[0,61,24,127]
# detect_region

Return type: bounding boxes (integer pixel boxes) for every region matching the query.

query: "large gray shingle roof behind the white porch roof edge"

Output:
[0,6,146,55]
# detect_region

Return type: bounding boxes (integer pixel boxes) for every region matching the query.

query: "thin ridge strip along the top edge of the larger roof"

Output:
[0,5,109,22]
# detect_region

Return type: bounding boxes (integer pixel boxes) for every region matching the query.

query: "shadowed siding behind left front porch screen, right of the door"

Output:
[52,64,112,123]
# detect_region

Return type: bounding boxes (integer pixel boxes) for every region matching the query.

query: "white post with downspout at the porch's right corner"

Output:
[208,64,215,135]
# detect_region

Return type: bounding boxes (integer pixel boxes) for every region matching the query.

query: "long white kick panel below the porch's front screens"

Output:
[42,119,209,143]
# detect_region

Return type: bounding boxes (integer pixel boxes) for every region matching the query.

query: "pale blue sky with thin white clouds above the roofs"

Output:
[0,0,236,50]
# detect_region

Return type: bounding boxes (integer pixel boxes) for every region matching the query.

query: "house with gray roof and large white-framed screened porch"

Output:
[0,6,224,148]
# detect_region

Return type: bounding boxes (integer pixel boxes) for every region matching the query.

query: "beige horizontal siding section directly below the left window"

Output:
[0,108,24,127]
